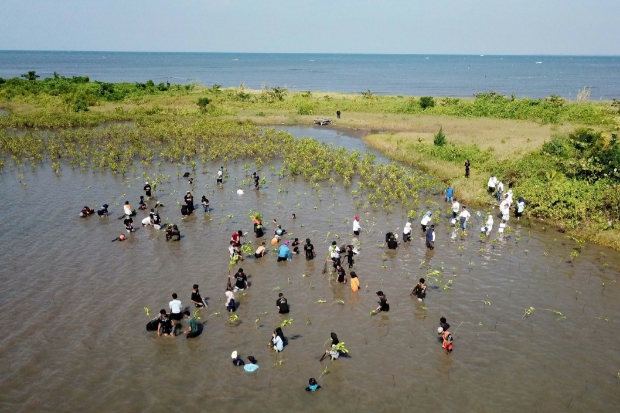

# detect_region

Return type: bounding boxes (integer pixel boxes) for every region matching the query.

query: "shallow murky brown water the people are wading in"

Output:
[0,129,620,413]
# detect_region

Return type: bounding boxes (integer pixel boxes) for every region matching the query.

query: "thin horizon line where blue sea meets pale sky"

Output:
[0,49,620,57]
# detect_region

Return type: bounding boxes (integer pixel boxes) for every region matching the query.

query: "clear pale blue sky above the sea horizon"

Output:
[0,0,620,55]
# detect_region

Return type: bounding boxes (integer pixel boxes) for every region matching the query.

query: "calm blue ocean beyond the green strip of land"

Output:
[0,51,620,100]
